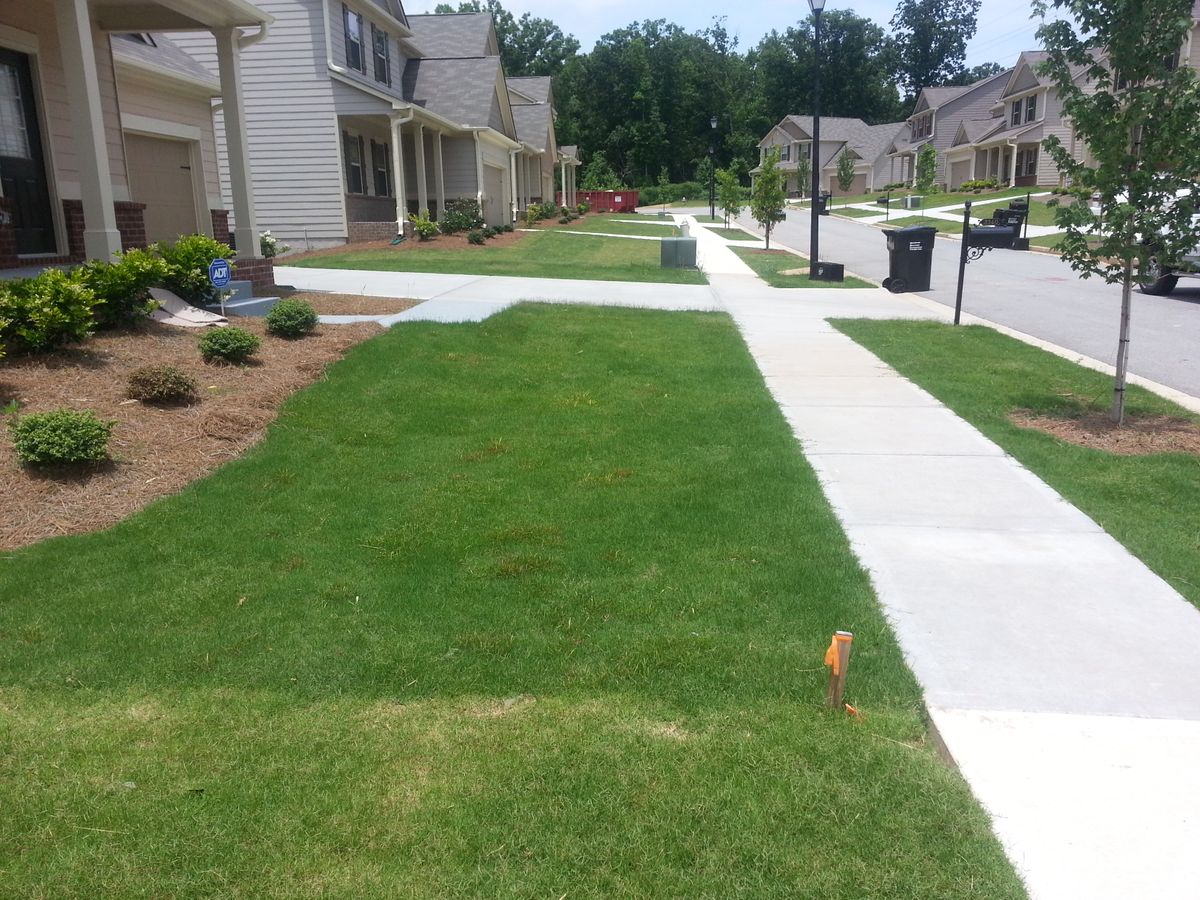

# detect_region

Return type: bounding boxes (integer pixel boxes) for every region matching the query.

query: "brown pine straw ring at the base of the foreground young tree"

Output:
[1008,409,1200,456]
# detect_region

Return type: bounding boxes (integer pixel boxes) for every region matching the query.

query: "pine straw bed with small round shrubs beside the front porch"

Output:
[0,317,380,550]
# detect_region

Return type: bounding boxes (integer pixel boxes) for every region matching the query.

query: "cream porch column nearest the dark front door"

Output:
[54,0,121,259]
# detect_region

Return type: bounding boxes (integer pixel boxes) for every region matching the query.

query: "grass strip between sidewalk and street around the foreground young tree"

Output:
[835,322,1200,625]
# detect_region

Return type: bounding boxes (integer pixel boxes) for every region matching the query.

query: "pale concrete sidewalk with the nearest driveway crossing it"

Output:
[277,228,1200,900]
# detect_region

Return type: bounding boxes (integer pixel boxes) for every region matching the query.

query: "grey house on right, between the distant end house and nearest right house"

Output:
[888,68,1014,186]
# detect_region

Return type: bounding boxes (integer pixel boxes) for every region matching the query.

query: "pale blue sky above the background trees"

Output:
[422,0,1051,67]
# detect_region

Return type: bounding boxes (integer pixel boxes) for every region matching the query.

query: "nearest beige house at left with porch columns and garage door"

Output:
[0,0,271,280]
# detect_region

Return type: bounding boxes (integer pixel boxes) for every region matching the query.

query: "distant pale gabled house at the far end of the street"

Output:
[750,115,902,197]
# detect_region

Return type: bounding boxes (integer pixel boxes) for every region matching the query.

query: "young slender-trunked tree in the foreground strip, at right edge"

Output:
[1033,0,1200,425]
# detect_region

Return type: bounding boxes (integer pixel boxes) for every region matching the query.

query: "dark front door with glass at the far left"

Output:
[0,48,54,253]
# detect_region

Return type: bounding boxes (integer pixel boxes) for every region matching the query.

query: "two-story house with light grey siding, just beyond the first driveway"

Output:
[172,0,554,248]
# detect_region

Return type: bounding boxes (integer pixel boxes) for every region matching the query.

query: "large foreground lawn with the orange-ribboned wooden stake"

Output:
[0,306,1024,900]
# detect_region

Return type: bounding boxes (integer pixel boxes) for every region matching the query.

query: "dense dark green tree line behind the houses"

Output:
[434,0,1001,187]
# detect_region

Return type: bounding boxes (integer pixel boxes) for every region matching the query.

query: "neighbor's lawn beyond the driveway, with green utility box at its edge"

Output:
[289,216,708,284]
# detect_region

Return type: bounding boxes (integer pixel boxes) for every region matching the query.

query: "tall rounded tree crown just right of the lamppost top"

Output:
[892,0,980,100]
